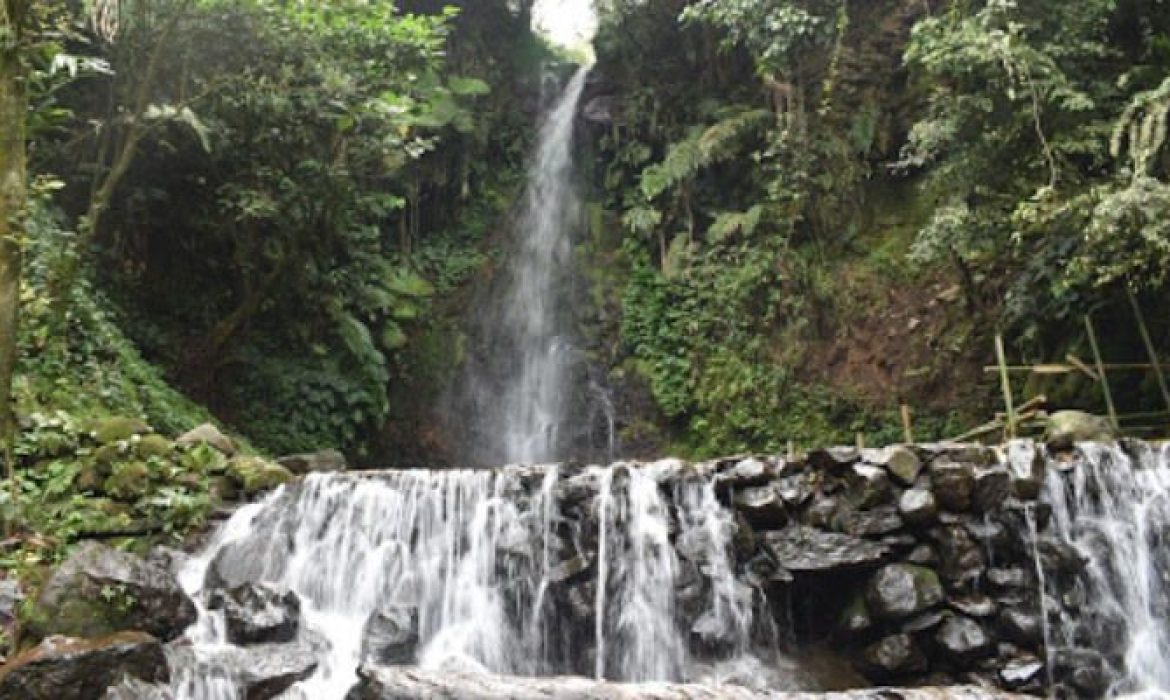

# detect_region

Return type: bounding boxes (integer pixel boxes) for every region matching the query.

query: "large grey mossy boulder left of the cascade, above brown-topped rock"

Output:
[29,542,197,641]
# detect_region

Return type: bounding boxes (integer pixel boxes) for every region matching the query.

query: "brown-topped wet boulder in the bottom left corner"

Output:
[0,632,170,700]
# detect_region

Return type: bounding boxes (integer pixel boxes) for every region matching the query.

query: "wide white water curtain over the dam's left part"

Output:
[172,461,791,700]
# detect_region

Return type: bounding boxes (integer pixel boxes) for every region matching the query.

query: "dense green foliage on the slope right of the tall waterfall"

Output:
[596,0,1170,452]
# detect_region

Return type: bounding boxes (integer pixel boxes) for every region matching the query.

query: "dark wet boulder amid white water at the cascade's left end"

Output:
[209,583,301,644]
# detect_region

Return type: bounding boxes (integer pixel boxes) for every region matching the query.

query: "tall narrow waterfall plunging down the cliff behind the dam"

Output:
[448,67,612,465]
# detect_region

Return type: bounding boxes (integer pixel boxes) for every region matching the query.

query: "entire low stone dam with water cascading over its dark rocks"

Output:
[117,441,1170,700]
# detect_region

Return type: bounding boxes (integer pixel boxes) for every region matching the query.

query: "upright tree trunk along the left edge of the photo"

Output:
[0,2,27,474]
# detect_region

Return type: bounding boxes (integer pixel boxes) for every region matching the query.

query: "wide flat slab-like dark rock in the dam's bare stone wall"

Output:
[763,526,889,574]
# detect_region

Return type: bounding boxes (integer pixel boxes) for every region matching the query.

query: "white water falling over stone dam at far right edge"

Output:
[1035,444,1170,696]
